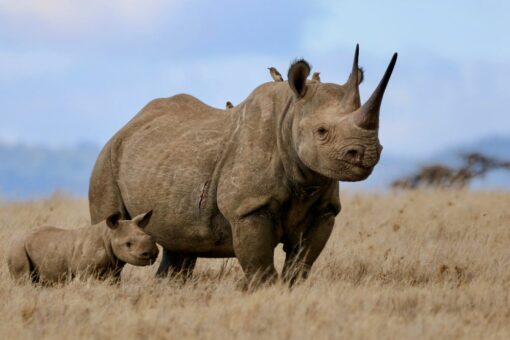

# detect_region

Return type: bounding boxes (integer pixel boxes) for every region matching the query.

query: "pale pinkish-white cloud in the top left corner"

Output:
[0,0,178,36]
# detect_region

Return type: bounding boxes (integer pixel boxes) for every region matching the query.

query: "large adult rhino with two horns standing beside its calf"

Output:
[89,48,396,283]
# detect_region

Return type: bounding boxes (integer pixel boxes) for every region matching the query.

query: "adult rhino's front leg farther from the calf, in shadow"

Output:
[282,212,335,285]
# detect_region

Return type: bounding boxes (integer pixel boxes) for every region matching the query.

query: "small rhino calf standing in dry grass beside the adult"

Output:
[7,211,159,283]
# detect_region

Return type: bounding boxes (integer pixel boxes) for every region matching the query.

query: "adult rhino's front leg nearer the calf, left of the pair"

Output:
[232,213,278,287]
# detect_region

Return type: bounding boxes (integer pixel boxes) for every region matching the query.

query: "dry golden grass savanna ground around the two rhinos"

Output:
[0,191,510,339]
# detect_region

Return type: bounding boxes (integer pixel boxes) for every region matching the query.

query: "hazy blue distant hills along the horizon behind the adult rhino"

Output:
[0,137,510,199]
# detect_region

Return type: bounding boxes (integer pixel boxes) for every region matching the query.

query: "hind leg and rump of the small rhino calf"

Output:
[7,237,39,283]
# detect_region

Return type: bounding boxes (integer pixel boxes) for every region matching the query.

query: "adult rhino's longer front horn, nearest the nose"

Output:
[354,53,398,130]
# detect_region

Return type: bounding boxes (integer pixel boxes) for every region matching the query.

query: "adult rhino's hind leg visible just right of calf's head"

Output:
[156,249,197,282]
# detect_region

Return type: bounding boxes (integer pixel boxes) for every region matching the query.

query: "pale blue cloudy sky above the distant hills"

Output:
[0,0,510,156]
